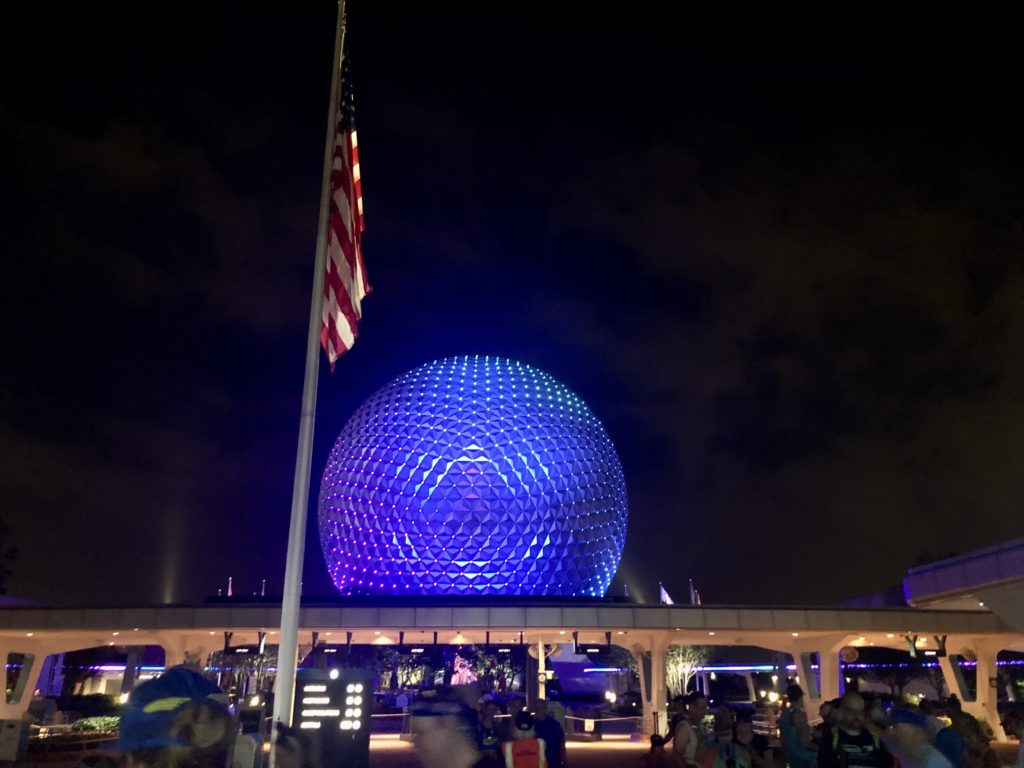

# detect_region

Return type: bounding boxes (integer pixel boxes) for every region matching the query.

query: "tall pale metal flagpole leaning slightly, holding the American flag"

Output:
[270,0,345,737]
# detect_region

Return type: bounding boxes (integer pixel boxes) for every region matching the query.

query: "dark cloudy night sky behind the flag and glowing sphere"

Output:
[0,0,1024,604]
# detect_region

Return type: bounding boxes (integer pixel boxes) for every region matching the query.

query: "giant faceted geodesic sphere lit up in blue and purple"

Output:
[318,357,627,597]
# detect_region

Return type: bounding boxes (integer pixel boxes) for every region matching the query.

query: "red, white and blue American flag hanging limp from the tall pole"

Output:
[321,56,371,371]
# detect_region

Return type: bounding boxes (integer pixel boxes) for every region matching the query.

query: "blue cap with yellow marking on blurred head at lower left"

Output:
[118,667,230,752]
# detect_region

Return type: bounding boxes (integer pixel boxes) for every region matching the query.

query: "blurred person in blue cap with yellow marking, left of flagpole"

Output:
[118,667,238,768]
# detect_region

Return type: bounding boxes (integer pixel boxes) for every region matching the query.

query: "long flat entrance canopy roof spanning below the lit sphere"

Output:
[0,598,1024,649]
